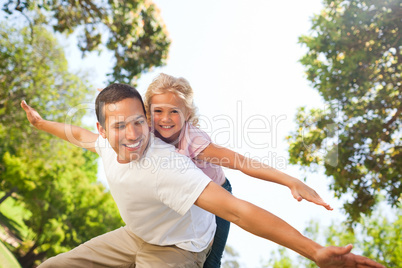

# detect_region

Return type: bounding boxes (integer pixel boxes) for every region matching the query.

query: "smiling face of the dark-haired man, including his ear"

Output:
[98,98,149,163]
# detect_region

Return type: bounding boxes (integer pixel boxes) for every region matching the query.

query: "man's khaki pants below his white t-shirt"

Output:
[39,227,211,268]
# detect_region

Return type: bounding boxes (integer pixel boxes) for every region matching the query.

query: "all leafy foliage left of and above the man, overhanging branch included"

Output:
[0,0,170,267]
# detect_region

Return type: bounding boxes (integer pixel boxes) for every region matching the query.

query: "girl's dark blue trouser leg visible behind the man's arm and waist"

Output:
[204,179,232,268]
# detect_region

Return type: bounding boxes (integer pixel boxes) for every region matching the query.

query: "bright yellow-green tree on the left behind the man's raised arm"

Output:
[0,22,122,267]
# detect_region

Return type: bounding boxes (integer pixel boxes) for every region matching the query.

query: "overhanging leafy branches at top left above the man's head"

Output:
[2,0,170,83]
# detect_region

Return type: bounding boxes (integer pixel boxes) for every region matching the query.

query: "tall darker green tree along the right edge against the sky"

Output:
[288,0,402,223]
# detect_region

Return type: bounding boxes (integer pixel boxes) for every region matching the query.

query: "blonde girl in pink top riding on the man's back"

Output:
[144,73,332,268]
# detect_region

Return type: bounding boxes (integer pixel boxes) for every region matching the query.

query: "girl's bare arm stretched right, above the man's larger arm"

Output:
[197,143,332,210]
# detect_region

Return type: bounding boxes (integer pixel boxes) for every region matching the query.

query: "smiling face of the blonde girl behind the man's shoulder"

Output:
[150,92,188,146]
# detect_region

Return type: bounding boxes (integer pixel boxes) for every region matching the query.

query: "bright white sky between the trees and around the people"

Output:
[65,0,345,268]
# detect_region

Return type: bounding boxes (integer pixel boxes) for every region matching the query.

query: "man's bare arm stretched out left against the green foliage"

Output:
[21,101,99,153]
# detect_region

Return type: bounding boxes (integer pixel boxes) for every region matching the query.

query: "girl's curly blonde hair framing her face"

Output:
[144,73,198,126]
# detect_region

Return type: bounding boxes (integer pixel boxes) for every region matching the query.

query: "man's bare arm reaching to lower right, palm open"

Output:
[195,182,384,268]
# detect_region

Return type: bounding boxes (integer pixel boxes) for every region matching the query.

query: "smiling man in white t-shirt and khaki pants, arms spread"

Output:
[21,84,383,268]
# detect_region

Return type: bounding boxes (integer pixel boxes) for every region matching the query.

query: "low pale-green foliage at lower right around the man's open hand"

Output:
[265,206,402,268]
